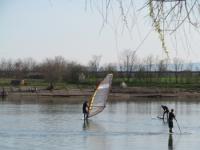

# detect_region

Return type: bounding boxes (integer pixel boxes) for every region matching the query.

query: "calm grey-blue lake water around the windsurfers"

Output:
[0,96,200,150]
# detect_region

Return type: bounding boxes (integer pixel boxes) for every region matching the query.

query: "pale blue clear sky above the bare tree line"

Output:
[0,0,200,64]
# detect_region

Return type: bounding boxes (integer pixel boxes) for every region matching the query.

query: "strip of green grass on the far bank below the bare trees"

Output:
[0,77,200,90]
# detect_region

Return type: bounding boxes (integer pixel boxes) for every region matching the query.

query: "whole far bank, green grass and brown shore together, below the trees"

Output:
[0,78,200,100]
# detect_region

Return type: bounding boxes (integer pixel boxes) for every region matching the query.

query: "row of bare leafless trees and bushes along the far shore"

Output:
[0,50,200,86]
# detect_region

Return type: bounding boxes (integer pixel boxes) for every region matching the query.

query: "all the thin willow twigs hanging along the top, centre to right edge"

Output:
[88,0,200,54]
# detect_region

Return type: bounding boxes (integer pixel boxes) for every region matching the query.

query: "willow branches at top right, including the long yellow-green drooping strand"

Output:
[148,0,200,55]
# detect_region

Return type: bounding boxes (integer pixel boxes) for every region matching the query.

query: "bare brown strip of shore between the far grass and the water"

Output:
[2,87,200,101]
